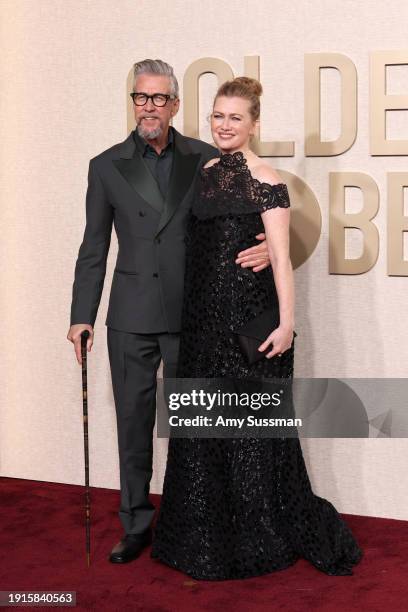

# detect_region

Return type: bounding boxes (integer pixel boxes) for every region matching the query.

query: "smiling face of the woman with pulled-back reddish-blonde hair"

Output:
[211,96,255,153]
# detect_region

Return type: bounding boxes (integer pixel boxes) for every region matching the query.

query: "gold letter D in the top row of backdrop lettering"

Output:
[305,53,357,157]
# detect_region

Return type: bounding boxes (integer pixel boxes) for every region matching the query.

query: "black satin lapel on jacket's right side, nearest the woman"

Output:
[157,137,201,234]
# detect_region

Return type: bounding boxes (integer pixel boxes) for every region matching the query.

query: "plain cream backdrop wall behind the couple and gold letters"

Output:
[0,0,408,519]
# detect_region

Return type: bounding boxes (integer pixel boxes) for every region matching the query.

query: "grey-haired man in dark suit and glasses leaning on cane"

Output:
[67,60,269,563]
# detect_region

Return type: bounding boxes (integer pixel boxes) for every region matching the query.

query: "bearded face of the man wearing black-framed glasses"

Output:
[133,74,180,140]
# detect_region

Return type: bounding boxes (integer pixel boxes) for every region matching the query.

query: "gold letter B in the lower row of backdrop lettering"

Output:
[329,172,379,274]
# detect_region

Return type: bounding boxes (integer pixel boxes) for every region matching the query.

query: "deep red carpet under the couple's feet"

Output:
[0,478,408,612]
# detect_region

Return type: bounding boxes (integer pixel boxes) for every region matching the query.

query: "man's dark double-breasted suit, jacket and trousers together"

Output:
[71,128,218,533]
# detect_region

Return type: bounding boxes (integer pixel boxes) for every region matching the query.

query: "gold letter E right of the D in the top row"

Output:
[370,50,408,155]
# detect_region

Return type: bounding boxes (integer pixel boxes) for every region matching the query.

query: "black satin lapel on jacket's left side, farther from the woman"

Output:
[112,135,164,213]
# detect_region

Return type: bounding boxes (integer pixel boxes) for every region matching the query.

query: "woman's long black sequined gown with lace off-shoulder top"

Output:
[151,152,362,580]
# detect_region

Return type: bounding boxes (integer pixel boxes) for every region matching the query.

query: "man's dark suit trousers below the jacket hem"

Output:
[107,327,179,533]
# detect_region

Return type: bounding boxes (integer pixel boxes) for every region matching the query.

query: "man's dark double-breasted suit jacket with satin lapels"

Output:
[71,128,218,333]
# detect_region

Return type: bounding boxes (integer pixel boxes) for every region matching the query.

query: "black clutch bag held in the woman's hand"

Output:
[234,310,297,365]
